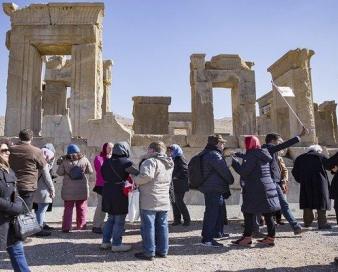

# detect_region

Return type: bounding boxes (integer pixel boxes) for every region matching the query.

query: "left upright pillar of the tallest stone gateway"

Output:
[5,42,42,136]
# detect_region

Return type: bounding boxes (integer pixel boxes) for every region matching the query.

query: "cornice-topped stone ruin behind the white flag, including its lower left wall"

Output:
[268,48,317,144]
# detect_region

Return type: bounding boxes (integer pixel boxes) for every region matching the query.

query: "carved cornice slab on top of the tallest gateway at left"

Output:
[3,3,104,26]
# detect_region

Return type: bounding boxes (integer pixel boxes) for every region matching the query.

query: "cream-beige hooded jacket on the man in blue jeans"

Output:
[134,153,174,211]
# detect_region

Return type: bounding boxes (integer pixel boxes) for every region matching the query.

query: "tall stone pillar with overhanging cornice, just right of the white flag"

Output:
[268,49,317,144]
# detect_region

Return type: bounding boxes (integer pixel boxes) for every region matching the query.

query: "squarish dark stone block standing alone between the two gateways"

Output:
[133,96,171,134]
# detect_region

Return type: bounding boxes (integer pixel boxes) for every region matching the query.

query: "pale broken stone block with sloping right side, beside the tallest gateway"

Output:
[87,112,131,147]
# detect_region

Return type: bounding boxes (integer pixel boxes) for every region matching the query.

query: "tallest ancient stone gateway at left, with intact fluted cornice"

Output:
[3,3,106,137]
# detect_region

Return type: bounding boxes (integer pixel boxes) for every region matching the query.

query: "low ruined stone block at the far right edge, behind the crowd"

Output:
[314,101,338,146]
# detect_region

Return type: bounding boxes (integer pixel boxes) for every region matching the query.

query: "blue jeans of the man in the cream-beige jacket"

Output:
[141,210,169,256]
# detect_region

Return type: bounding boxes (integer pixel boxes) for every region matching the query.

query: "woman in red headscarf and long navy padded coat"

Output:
[232,135,280,246]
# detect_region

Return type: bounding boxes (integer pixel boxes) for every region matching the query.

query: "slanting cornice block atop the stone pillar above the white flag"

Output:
[267,48,315,79]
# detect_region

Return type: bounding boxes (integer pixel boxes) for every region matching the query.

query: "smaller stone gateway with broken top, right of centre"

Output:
[190,54,256,136]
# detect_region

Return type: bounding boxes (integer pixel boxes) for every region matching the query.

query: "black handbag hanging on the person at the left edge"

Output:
[13,196,41,240]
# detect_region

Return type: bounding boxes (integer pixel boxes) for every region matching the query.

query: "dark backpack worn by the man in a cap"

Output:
[188,151,209,189]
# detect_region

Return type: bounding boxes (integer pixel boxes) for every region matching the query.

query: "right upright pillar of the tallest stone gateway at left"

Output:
[70,43,103,138]
